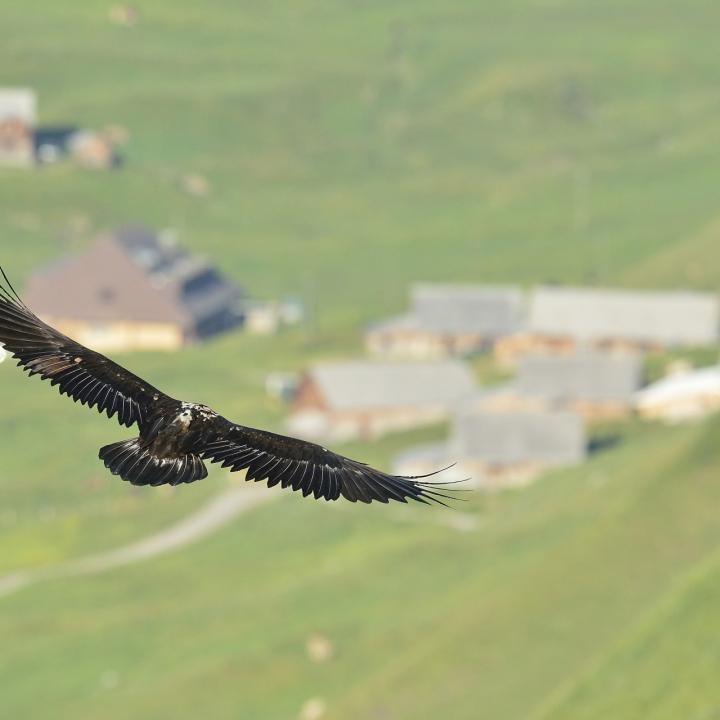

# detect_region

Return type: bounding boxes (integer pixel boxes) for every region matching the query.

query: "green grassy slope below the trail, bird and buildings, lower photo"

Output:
[0,414,720,720]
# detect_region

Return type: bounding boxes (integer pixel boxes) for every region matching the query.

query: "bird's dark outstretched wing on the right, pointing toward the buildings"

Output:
[202,416,456,504]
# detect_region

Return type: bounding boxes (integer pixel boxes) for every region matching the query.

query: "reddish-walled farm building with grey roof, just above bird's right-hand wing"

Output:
[288,360,476,440]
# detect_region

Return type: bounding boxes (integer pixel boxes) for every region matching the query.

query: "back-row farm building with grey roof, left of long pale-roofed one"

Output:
[365,284,525,359]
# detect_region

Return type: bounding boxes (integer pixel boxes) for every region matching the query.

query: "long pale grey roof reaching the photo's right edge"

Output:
[530,287,720,346]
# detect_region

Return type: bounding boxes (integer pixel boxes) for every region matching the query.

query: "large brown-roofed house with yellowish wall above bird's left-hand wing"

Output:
[25,226,242,351]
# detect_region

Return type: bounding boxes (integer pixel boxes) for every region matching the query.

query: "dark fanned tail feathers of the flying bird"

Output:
[100,438,207,485]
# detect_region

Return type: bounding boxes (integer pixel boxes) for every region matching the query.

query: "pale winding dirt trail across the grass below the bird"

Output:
[0,485,279,598]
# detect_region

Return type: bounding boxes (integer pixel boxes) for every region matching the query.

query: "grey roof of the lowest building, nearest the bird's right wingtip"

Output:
[449,410,586,465]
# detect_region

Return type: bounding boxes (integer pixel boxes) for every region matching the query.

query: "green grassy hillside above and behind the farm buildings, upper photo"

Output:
[0,0,720,322]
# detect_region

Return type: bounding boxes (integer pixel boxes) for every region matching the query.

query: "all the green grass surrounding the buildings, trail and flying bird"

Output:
[0,0,720,720]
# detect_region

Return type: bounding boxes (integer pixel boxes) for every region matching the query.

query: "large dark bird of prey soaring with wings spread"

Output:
[0,268,458,505]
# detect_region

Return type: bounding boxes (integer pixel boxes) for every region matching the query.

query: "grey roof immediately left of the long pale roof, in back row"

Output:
[411,284,526,337]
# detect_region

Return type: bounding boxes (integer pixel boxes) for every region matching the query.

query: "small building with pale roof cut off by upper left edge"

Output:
[0,88,37,167]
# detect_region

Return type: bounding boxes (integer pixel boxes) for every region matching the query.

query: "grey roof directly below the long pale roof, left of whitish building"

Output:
[515,352,643,402]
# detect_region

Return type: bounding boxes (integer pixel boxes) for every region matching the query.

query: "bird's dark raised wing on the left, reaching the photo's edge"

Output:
[0,268,162,427]
